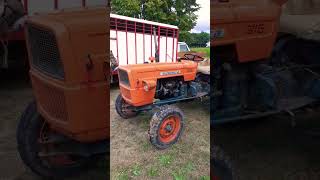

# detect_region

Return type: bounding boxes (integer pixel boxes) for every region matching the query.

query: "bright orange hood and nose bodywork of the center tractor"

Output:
[119,61,198,106]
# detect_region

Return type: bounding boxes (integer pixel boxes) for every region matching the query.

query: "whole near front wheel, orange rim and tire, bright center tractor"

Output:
[149,106,184,149]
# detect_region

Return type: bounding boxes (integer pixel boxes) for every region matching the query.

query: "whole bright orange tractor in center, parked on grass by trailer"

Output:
[115,54,210,149]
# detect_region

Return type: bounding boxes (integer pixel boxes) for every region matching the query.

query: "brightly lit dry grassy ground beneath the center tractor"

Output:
[110,87,210,180]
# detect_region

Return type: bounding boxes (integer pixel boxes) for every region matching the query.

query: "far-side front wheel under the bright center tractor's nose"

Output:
[115,94,138,119]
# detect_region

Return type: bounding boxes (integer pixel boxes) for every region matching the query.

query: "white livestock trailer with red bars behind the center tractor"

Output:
[110,14,179,83]
